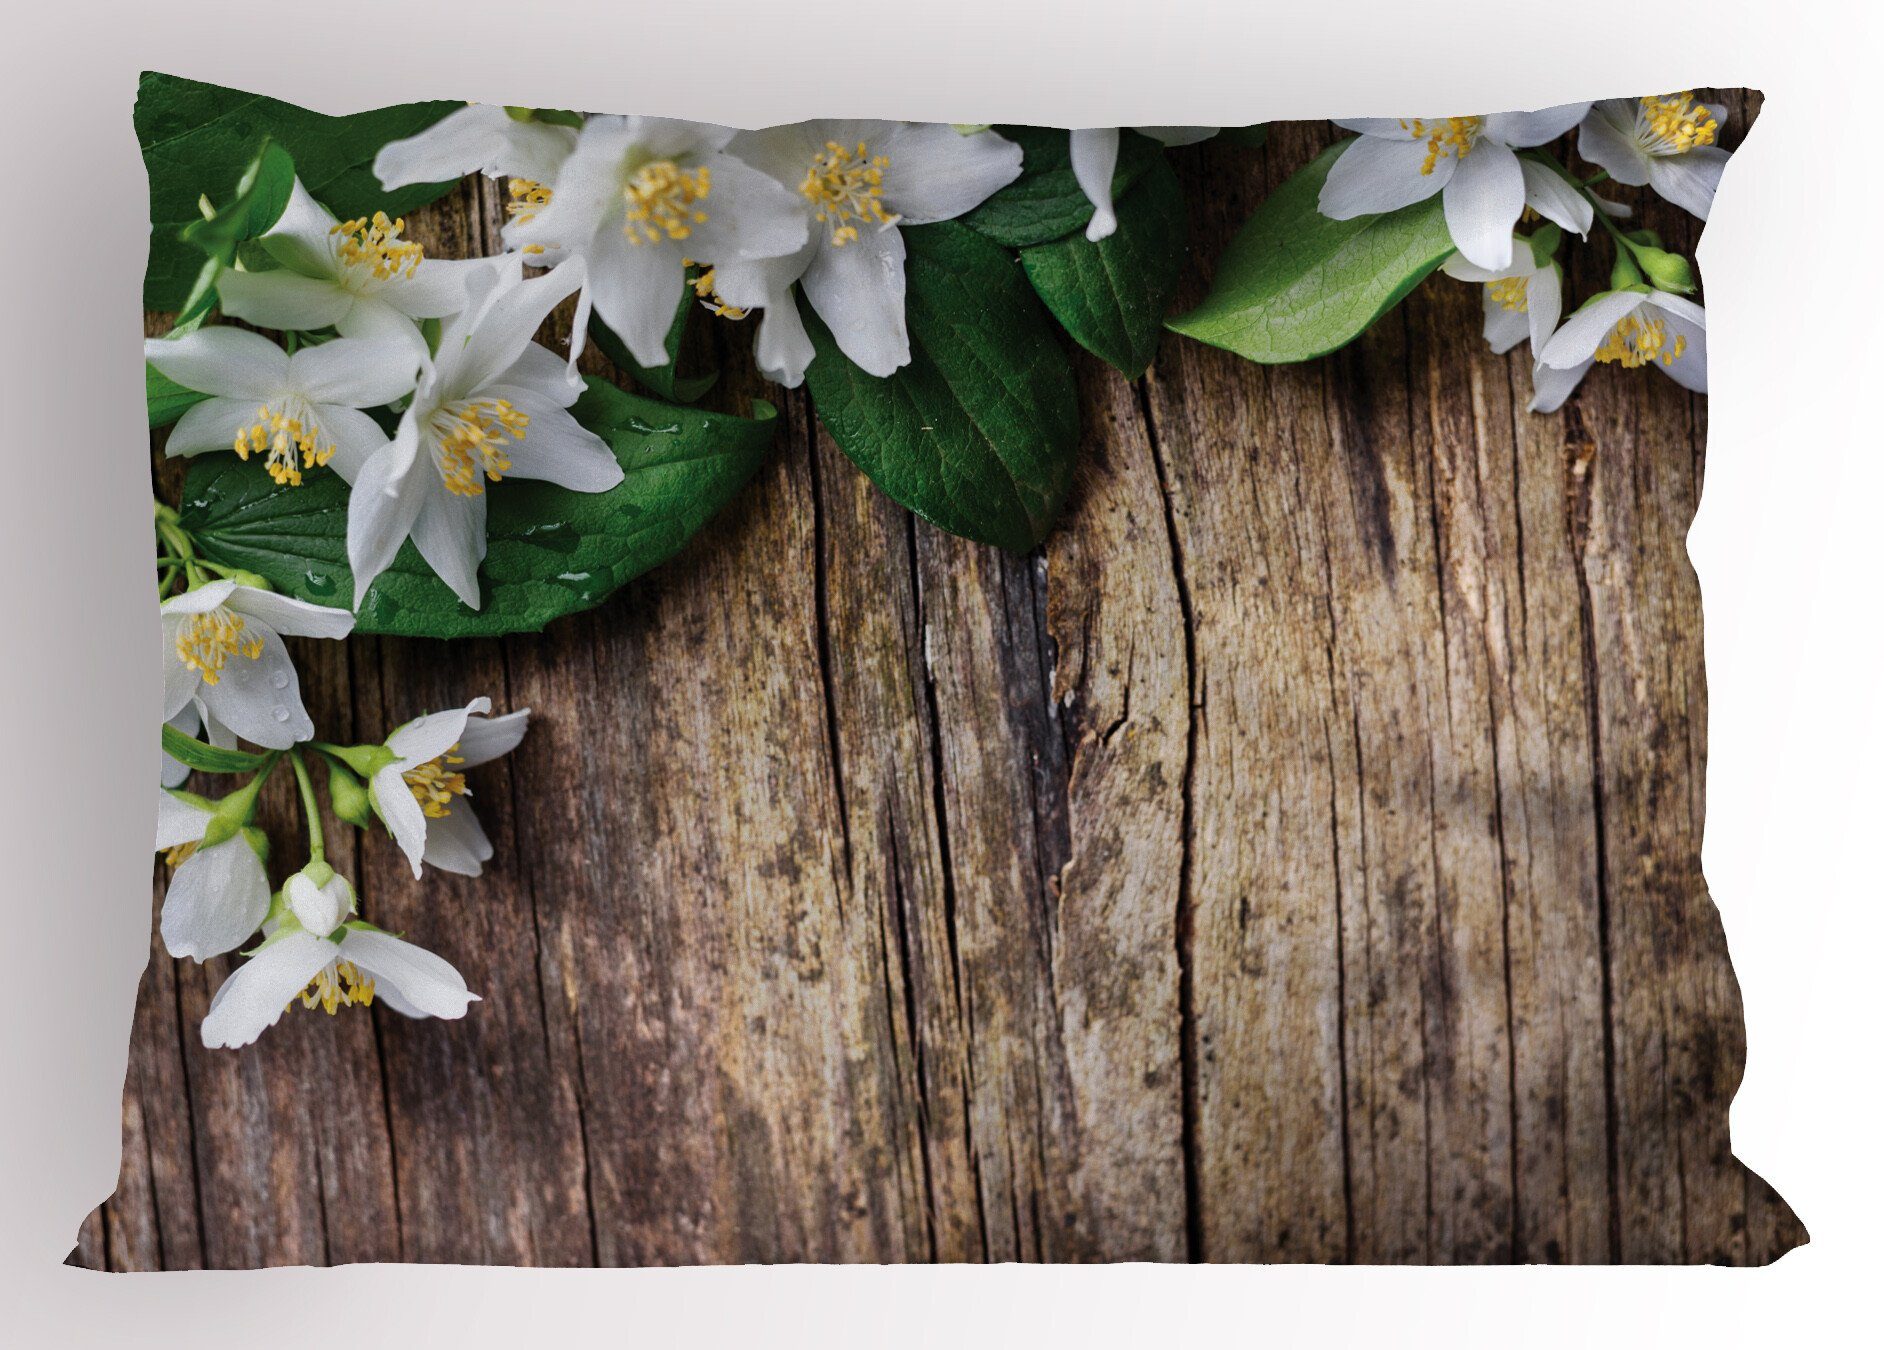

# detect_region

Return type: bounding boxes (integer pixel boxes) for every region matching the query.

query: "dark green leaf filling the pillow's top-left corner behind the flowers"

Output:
[134,72,463,309]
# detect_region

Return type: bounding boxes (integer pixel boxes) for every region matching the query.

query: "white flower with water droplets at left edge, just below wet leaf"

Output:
[162,580,354,749]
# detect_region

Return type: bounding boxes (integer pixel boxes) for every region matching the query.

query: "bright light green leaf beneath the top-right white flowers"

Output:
[1170,139,1453,363]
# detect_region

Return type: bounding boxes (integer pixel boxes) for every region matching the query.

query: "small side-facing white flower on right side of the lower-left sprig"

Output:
[369,699,529,877]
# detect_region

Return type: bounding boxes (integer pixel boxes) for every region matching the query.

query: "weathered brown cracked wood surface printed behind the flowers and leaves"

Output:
[73,98,1805,1269]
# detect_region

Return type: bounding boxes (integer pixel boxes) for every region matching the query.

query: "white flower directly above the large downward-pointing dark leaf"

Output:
[701,121,1021,386]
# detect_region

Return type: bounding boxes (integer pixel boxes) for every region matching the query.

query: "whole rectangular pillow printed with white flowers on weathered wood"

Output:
[84,73,1805,1269]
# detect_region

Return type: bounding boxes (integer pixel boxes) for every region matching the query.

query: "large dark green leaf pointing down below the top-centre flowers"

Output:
[801,222,1080,552]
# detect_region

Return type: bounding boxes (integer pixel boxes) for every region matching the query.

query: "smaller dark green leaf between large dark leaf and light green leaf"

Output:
[1021,158,1187,380]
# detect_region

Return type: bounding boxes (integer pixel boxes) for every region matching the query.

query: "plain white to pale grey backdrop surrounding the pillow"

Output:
[0,0,1884,1346]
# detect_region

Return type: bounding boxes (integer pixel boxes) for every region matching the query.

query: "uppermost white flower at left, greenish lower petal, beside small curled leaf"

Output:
[217,181,486,362]
